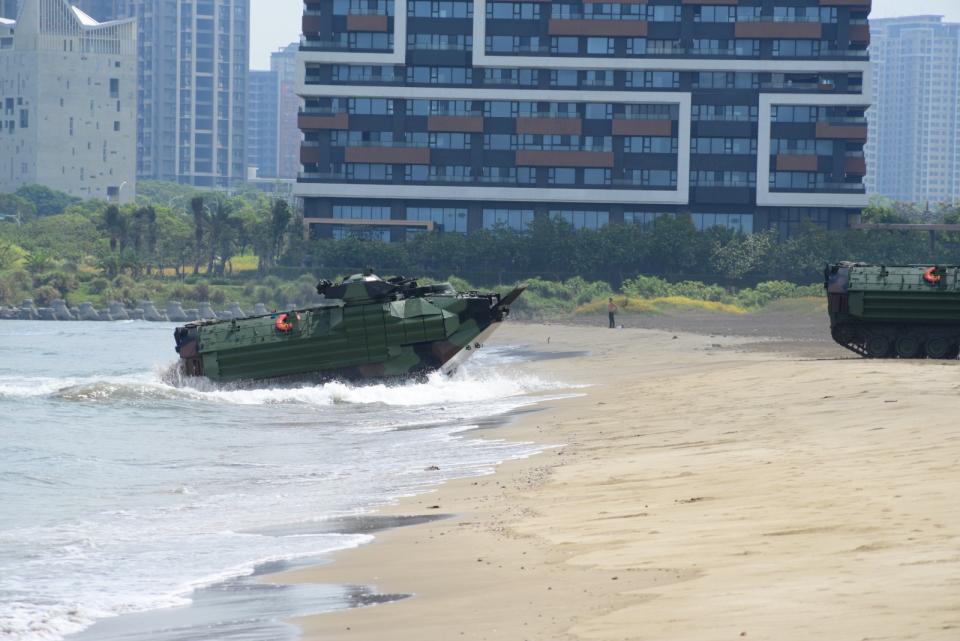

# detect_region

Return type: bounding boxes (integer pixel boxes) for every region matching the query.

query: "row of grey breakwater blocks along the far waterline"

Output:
[0,298,278,323]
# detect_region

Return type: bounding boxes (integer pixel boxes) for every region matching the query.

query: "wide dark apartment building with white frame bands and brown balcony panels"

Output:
[297,0,870,238]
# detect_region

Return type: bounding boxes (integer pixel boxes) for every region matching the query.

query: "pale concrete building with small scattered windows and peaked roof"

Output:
[0,0,137,203]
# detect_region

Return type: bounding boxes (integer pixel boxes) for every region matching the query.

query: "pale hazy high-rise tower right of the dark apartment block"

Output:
[866,16,960,203]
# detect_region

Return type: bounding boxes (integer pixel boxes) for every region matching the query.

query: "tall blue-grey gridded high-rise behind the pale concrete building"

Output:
[78,0,250,187]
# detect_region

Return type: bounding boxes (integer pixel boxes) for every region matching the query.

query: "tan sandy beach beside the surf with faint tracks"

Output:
[270,317,960,641]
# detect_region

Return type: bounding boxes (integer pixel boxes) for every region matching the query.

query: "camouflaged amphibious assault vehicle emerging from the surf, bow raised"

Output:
[174,272,523,381]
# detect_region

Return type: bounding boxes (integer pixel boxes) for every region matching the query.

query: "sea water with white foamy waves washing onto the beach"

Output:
[0,321,560,641]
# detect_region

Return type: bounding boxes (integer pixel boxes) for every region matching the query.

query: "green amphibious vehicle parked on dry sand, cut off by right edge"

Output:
[824,263,960,359]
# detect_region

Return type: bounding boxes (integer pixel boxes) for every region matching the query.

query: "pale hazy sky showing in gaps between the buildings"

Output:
[250,0,960,69]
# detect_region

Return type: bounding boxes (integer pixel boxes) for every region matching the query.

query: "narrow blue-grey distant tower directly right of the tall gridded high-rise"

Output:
[247,71,280,178]
